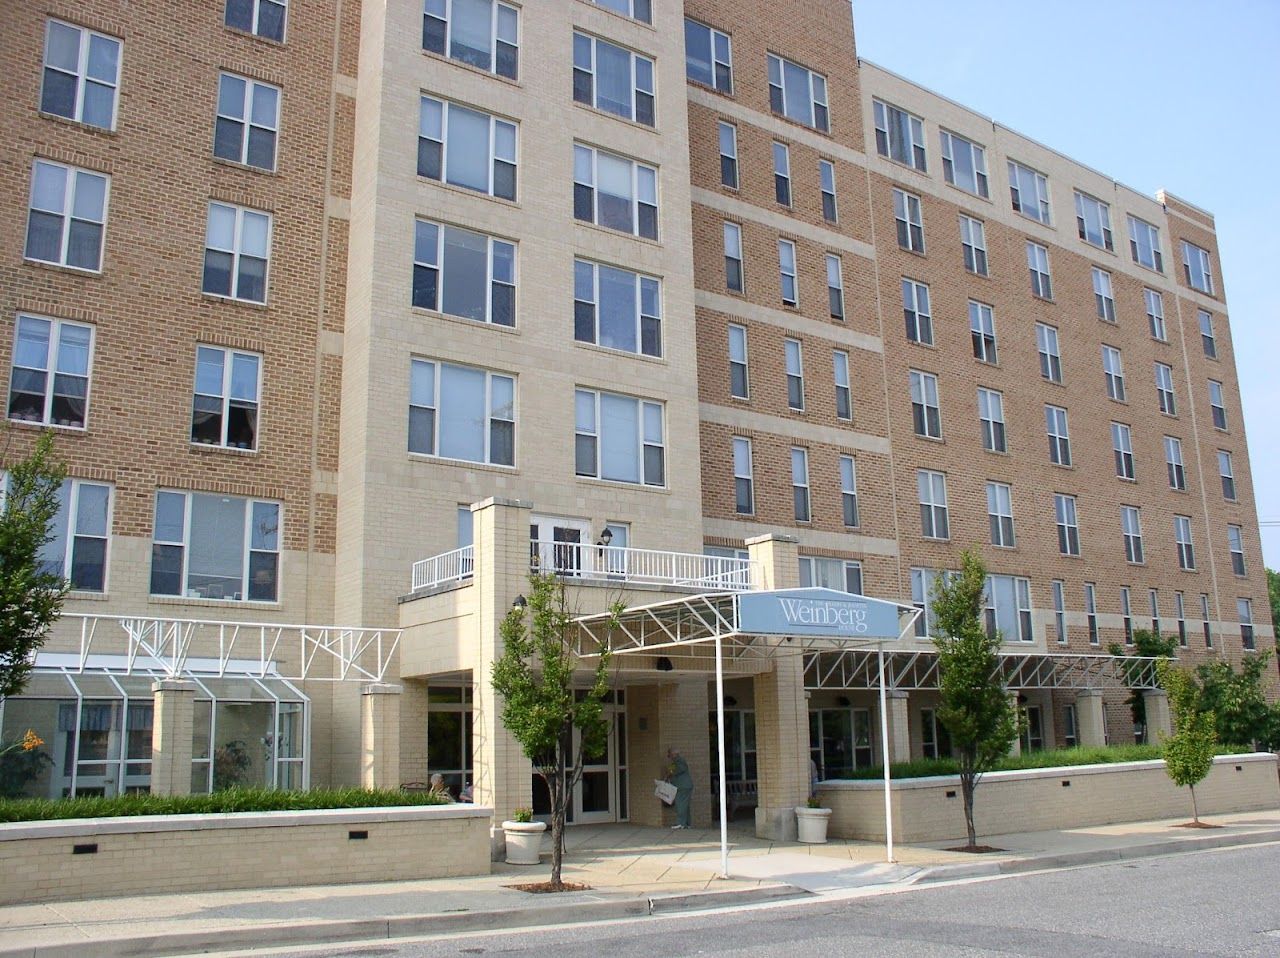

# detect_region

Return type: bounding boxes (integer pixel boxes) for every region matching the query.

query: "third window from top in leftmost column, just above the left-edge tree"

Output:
[8,315,93,429]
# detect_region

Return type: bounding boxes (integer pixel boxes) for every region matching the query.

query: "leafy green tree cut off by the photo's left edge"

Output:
[0,433,67,697]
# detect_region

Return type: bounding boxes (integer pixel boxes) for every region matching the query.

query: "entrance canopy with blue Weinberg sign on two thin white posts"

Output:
[573,588,920,879]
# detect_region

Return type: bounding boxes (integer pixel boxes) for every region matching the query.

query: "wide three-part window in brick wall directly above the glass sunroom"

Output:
[151,491,280,602]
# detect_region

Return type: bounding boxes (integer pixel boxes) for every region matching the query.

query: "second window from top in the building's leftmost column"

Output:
[26,160,110,273]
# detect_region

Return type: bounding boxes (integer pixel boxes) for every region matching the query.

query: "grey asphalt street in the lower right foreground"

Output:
[262,845,1280,958]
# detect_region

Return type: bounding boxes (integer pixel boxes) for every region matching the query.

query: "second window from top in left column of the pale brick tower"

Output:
[417,96,516,200]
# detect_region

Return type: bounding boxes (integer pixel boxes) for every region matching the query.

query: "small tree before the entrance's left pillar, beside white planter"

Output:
[493,572,618,890]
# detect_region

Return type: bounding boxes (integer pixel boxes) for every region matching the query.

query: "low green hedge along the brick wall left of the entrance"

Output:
[0,788,445,822]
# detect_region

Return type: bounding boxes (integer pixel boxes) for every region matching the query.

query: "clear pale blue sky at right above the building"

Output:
[854,0,1280,569]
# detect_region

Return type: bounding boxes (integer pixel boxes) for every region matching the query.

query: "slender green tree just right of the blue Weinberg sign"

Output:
[933,549,1018,848]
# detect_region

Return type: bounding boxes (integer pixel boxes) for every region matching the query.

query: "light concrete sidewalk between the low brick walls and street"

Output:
[0,811,1280,958]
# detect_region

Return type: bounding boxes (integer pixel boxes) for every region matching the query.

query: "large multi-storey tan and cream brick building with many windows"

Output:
[0,0,1274,834]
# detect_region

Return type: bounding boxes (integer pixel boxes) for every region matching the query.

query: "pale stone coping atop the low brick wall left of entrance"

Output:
[0,803,493,841]
